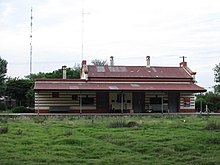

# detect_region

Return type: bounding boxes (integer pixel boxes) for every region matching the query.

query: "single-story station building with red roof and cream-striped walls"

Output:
[34,56,206,113]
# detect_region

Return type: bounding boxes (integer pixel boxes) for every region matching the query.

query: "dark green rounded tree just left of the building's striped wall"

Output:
[5,78,33,106]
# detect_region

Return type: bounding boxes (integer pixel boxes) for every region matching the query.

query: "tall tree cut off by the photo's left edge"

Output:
[0,57,8,96]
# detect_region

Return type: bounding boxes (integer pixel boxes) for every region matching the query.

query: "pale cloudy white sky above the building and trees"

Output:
[0,0,220,90]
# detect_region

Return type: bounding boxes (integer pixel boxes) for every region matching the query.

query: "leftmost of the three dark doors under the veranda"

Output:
[96,92,109,113]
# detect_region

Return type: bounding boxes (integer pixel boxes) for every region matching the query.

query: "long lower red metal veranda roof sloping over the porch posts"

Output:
[34,80,206,92]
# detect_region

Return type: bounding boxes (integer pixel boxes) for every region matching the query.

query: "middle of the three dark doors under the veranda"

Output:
[133,92,145,113]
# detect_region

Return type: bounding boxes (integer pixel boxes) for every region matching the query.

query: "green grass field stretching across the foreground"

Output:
[0,116,220,165]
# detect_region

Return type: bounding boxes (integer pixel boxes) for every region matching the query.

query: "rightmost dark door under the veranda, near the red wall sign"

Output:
[168,92,180,113]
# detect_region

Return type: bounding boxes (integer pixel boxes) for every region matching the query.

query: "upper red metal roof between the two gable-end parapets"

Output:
[88,65,192,79]
